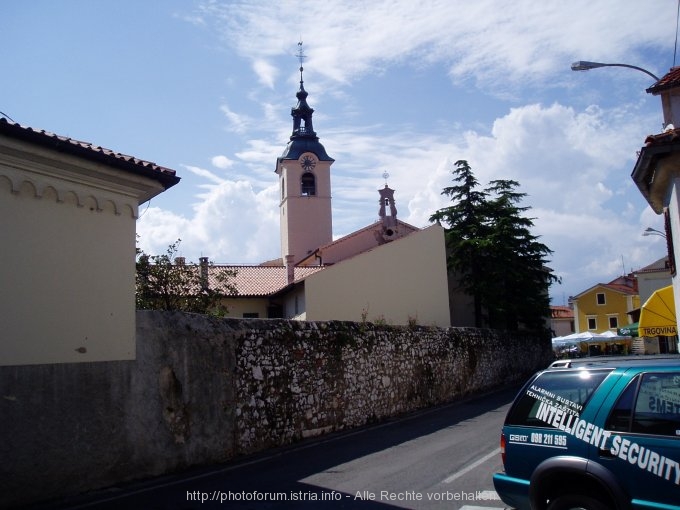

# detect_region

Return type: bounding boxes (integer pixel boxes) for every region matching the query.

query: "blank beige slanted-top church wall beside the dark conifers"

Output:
[305,225,450,327]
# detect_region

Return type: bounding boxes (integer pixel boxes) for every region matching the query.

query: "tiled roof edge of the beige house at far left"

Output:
[0,118,180,189]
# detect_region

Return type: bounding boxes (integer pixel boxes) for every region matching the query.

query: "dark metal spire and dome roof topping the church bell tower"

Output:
[279,42,335,165]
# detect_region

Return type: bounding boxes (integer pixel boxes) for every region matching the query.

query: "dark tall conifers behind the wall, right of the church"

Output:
[430,160,559,331]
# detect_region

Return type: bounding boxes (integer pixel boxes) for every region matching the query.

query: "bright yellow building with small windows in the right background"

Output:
[571,275,640,333]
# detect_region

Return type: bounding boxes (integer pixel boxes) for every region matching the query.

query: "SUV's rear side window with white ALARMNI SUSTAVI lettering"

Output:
[505,369,611,427]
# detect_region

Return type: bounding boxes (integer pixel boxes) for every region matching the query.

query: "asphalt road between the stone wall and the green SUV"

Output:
[40,387,518,510]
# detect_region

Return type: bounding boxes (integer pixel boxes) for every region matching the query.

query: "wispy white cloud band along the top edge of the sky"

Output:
[195,0,675,90]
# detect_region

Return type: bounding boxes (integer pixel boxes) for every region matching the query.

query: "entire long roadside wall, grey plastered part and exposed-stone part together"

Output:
[0,312,551,508]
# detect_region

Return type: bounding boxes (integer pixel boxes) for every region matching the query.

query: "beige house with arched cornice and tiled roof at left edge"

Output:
[0,118,179,366]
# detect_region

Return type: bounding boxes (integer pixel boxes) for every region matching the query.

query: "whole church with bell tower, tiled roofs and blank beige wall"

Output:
[208,56,450,327]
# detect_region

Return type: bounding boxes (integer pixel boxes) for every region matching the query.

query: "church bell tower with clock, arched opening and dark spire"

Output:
[276,43,335,263]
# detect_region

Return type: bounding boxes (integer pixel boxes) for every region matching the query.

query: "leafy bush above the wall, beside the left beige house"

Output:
[135,239,236,315]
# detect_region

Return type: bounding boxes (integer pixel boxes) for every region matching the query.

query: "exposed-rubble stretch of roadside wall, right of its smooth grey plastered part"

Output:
[236,322,551,452]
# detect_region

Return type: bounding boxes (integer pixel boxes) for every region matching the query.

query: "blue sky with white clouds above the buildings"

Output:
[0,0,677,304]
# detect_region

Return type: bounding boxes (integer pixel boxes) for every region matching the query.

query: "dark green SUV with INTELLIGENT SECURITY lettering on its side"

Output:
[493,356,680,510]
